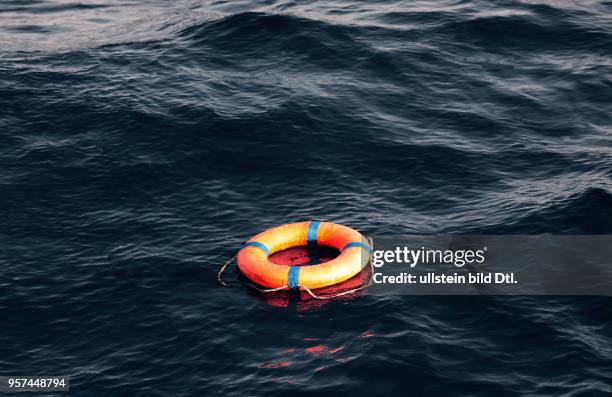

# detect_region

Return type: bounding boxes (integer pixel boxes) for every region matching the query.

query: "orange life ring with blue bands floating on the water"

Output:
[237,221,372,289]
